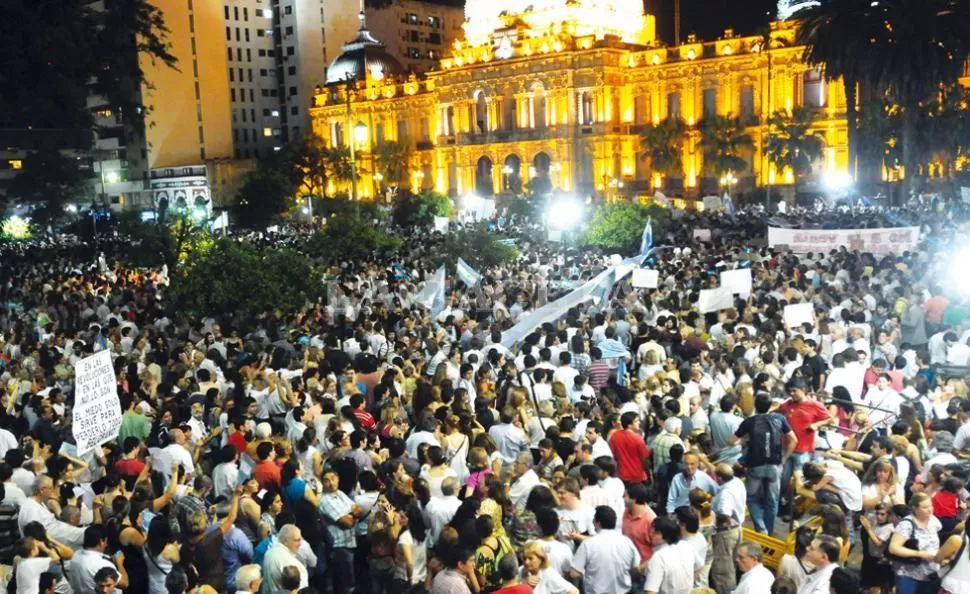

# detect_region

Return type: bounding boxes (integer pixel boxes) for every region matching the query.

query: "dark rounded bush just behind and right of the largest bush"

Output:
[305,209,404,262]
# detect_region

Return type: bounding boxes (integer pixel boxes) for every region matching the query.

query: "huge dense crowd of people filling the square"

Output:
[0,201,970,594]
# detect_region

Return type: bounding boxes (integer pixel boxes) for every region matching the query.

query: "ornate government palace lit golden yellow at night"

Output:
[310,0,848,198]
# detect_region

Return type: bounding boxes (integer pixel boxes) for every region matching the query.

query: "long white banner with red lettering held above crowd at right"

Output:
[768,227,919,256]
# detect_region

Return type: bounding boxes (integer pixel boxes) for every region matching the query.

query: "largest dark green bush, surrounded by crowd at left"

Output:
[172,238,323,319]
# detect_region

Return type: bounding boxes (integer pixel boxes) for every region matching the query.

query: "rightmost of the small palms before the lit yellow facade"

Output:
[765,107,825,188]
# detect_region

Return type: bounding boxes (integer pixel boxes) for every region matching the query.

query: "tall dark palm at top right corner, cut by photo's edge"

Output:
[873,0,970,194]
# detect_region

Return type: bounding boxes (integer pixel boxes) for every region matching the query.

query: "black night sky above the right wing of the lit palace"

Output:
[644,0,778,44]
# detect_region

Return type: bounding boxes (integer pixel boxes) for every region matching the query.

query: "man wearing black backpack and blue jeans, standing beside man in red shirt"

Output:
[730,392,798,534]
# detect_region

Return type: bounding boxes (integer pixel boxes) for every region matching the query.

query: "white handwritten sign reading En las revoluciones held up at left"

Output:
[71,350,121,456]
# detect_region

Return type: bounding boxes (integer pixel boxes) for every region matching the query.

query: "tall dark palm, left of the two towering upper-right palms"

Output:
[795,0,885,182]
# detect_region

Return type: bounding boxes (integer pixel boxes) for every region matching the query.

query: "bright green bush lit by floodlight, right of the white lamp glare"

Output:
[586,202,670,253]
